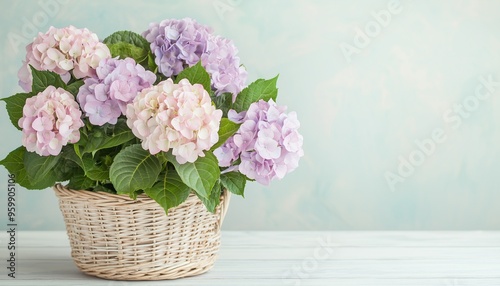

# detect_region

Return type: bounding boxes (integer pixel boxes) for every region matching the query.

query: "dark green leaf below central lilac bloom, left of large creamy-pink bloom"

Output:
[83,119,136,153]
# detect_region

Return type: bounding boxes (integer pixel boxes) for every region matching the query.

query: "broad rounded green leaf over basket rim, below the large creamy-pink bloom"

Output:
[109,144,161,194]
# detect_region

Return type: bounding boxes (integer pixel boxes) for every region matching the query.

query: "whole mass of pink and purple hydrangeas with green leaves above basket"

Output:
[0,18,303,212]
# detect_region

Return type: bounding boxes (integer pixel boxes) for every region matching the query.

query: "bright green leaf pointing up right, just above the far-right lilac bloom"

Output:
[233,76,278,112]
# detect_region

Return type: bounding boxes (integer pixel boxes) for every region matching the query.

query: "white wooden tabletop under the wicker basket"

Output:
[0,231,500,286]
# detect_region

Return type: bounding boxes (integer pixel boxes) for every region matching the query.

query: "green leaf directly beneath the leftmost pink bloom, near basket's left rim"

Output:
[23,152,61,187]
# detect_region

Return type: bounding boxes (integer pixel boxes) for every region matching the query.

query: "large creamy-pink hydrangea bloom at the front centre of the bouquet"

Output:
[127,78,222,164]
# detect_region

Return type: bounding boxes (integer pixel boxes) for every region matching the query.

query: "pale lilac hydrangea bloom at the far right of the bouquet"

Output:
[214,99,304,185]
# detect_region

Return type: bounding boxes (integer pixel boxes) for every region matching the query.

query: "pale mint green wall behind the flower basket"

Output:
[0,0,500,230]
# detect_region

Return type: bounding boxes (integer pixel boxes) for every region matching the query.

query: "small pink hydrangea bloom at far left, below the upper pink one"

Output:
[18,86,84,156]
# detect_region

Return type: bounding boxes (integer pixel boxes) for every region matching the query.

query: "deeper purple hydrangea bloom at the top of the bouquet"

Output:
[142,18,211,77]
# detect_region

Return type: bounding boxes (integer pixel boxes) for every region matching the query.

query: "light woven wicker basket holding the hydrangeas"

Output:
[54,184,230,280]
